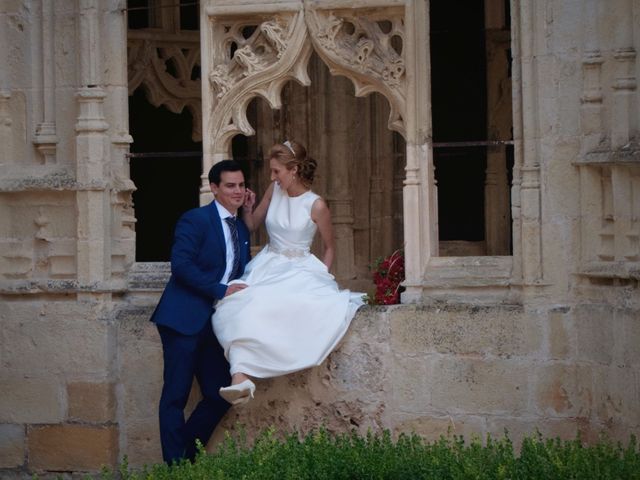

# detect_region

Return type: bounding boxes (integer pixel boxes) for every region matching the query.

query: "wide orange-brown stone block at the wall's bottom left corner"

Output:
[27,425,118,471]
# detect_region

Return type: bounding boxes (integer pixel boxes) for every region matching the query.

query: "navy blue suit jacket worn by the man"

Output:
[151,202,250,335]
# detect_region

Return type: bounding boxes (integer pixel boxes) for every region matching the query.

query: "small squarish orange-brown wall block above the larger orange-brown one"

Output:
[67,382,116,423]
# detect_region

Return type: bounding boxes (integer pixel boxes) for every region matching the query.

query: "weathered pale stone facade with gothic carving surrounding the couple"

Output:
[0,0,640,477]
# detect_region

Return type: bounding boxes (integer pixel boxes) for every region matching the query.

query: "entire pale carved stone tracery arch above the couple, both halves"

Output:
[207,2,407,154]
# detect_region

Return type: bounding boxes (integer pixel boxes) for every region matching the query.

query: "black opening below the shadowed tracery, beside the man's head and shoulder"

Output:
[129,88,202,262]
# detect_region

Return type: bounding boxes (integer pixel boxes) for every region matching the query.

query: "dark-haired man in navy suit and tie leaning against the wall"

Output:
[151,160,249,463]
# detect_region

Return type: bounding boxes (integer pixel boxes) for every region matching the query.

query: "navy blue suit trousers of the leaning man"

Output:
[157,321,231,464]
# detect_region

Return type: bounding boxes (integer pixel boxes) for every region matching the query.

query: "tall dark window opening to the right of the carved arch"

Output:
[430,0,513,256]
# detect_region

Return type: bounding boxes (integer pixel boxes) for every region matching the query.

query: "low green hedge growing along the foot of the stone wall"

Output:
[103,429,640,480]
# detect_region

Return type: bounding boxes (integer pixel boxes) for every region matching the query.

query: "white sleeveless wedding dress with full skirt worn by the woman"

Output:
[212,183,364,378]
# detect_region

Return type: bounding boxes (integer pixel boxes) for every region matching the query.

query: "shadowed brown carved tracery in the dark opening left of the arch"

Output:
[128,39,202,142]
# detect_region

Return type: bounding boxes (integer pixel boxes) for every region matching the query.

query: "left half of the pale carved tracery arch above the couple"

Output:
[208,11,311,152]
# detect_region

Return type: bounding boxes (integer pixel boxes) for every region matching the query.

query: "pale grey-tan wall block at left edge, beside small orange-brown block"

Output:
[0,373,66,423]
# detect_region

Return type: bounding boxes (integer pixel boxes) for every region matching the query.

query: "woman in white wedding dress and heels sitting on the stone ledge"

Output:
[212,141,363,404]
